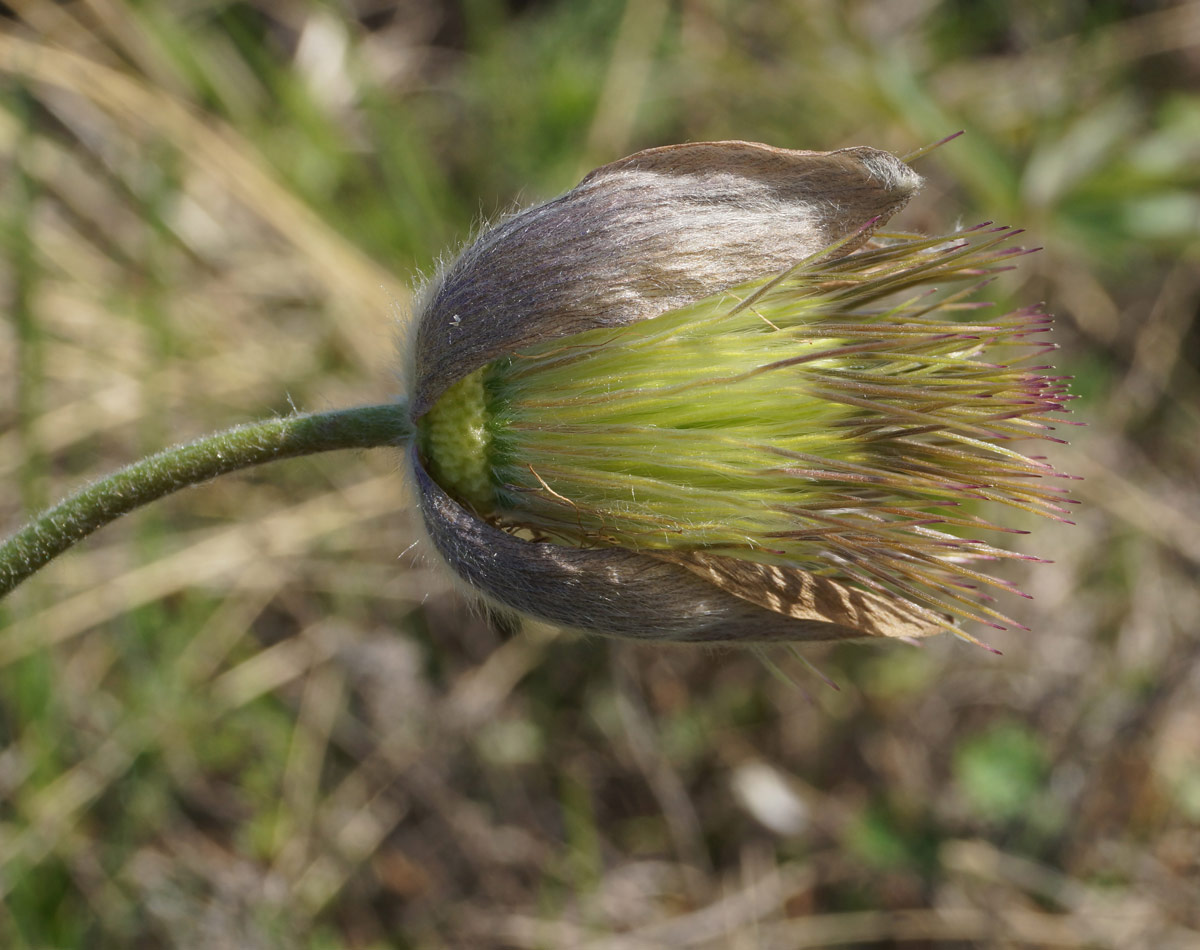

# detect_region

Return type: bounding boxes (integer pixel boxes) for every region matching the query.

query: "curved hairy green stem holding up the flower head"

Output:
[0,402,413,597]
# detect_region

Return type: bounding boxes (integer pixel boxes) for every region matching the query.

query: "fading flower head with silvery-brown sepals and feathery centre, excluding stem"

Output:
[407,142,1058,642]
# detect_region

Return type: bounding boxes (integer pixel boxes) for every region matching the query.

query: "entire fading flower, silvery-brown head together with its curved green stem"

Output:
[0,142,1069,644]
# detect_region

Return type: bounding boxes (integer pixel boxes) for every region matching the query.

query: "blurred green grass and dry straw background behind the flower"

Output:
[0,0,1200,950]
